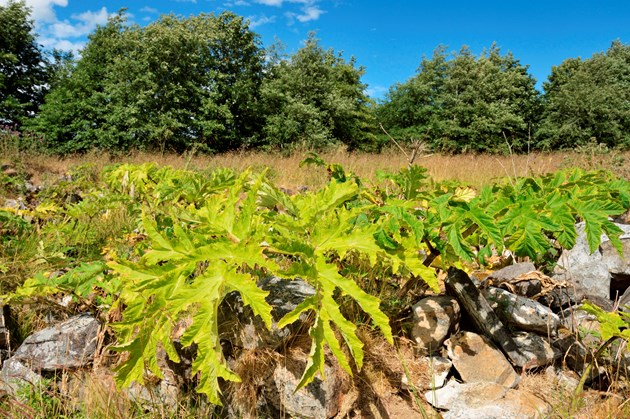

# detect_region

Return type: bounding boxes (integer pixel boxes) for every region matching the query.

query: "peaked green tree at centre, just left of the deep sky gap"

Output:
[262,33,376,149]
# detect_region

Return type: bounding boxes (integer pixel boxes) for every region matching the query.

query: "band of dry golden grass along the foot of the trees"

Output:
[0,148,630,188]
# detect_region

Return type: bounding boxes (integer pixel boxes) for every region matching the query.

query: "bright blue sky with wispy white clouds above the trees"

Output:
[0,0,630,98]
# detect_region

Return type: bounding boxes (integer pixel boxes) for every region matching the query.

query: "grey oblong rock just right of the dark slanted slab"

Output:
[482,287,560,335]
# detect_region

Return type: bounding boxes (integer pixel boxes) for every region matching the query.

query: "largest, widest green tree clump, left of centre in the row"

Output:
[31,11,263,152]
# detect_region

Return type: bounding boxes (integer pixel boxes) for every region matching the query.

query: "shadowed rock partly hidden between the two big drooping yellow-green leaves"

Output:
[218,277,315,349]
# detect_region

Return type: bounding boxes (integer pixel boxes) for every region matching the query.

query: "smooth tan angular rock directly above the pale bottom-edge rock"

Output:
[445,332,519,387]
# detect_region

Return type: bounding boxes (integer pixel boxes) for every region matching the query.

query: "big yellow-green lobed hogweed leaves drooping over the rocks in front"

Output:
[110,172,437,403]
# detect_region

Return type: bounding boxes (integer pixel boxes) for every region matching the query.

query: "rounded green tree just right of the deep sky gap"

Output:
[377,45,539,152]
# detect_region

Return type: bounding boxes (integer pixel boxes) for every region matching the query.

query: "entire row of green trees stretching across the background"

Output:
[0,1,630,154]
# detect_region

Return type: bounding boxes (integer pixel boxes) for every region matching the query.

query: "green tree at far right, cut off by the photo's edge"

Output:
[536,41,630,149]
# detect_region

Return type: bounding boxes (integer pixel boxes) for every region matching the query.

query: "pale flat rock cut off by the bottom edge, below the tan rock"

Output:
[425,380,549,419]
